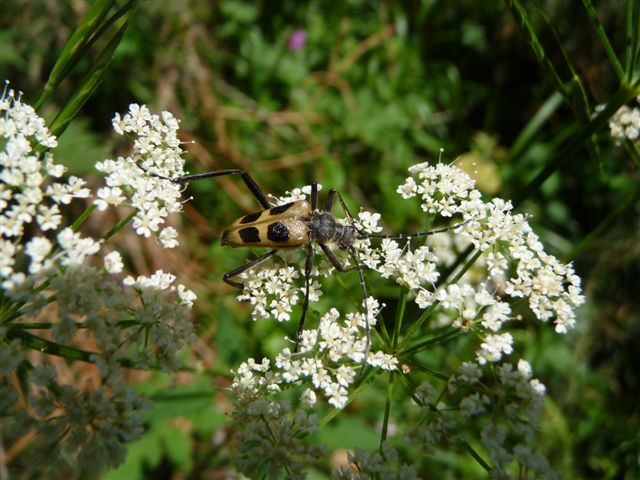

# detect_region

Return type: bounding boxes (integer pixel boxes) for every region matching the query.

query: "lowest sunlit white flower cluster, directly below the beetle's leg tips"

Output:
[231,298,398,408]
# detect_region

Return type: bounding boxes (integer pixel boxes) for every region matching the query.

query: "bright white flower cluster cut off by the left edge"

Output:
[0,87,89,288]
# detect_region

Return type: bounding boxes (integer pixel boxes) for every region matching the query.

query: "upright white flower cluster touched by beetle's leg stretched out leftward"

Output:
[95,104,185,248]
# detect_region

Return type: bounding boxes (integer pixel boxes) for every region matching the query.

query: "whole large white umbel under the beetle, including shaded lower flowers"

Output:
[226,159,584,478]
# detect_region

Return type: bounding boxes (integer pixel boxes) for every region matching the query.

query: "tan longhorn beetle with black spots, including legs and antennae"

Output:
[146,167,470,355]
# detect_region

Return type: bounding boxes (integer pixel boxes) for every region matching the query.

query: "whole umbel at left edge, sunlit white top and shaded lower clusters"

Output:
[0,91,195,478]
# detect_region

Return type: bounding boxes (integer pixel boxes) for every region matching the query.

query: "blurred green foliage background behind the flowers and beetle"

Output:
[0,0,640,479]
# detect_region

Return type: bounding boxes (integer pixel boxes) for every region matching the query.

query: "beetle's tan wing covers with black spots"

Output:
[222,200,311,248]
